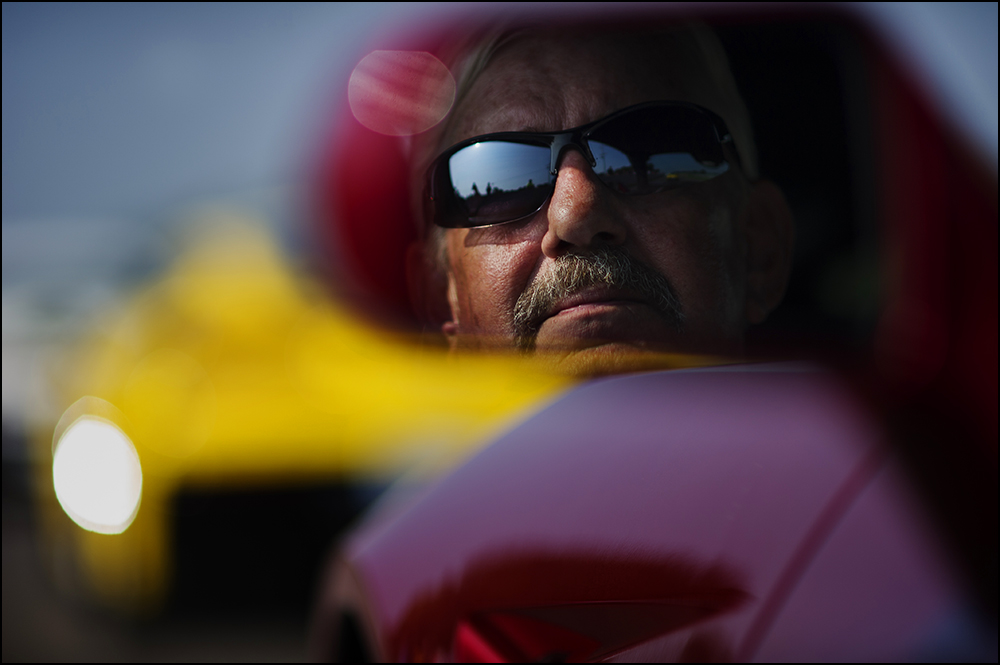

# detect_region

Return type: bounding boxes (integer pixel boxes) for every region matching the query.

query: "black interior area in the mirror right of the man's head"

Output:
[716,20,879,355]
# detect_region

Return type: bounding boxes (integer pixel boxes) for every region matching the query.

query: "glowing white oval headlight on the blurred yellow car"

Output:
[52,416,142,534]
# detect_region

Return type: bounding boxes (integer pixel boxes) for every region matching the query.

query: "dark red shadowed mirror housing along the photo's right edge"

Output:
[858,16,998,617]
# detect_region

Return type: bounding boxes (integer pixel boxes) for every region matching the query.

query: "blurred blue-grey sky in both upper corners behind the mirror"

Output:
[2,3,997,225]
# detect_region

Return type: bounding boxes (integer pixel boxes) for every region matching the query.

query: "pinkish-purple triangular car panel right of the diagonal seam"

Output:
[745,456,968,662]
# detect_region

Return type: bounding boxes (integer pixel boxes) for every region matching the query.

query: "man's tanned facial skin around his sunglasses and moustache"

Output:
[443,32,764,371]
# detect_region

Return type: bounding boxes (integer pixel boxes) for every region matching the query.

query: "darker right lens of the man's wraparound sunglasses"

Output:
[590,107,729,194]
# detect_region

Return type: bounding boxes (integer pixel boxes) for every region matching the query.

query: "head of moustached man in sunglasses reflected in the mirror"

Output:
[410,27,793,374]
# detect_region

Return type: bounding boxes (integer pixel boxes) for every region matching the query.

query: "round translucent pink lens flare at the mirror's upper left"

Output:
[347,51,455,136]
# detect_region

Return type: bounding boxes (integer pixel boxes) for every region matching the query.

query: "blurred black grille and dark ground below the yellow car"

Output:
[2,454,379,662]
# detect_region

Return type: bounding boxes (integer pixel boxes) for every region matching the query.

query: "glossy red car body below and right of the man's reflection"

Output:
[313,3,997,661]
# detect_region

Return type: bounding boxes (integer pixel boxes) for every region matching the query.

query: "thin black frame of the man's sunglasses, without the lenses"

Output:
[424,101,740,228]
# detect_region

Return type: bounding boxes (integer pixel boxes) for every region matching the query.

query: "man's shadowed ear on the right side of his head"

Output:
[744,180,795,323]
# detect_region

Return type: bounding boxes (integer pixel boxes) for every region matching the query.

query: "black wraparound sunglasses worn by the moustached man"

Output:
[424,102,739,228]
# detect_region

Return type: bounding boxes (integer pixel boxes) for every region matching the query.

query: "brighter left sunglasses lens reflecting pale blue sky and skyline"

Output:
[443,141,552,227]
